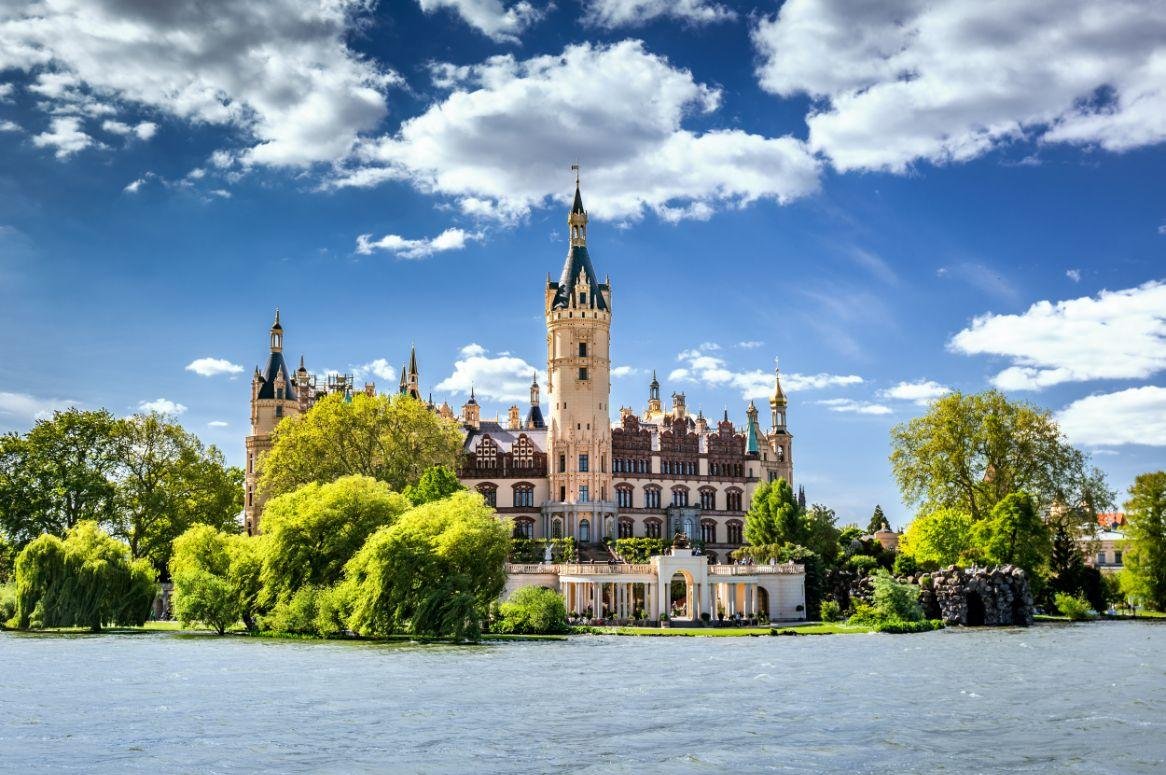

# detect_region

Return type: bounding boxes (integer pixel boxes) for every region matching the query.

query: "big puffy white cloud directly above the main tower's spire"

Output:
[331,41,819,220]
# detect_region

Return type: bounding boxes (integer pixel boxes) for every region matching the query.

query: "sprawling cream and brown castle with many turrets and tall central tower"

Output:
[245,177,802,618]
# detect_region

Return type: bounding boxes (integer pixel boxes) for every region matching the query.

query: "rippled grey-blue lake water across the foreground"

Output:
[0,622,1166,773]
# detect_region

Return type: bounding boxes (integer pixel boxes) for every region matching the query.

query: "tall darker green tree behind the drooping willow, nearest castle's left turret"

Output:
[111,413,243,571]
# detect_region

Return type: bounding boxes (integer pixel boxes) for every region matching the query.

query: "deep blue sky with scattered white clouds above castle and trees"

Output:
[0,0,1166,527]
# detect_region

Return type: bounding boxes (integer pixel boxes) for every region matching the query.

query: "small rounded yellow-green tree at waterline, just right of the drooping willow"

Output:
[170,524,259,635]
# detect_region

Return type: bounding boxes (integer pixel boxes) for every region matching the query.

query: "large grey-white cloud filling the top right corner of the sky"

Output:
[753,0,1166,172]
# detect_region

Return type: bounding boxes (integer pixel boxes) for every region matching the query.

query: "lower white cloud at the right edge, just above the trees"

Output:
[1056,386,1166,446]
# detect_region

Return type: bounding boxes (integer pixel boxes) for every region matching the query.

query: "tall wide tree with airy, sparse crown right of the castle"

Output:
[891,390,1112,521]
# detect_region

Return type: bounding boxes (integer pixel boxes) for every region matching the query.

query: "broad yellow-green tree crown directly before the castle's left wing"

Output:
[259,393,462,498]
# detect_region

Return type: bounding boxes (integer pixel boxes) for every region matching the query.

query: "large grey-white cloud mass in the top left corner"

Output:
[0,0,398,165]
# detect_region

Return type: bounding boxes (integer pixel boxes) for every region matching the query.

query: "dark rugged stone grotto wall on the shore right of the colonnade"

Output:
[913,565,1033,627]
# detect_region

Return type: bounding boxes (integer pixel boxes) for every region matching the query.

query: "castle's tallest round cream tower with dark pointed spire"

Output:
[546,176,614,541]
